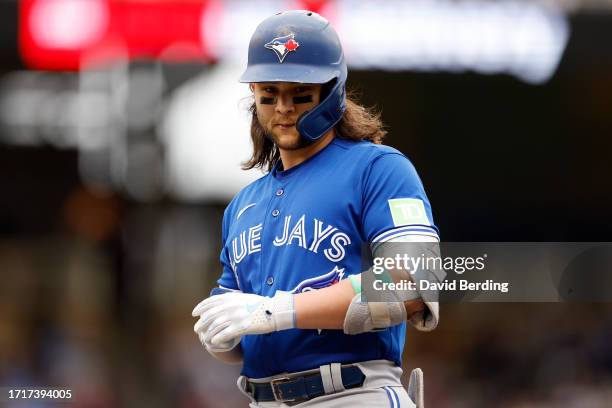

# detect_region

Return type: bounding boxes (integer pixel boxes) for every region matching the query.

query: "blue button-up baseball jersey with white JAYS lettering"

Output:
[218,138,438,378]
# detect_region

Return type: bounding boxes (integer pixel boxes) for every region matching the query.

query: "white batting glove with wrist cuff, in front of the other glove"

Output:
[191,292,295,347]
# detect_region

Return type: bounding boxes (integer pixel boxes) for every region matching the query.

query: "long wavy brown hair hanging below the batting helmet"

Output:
[242,92,387,171]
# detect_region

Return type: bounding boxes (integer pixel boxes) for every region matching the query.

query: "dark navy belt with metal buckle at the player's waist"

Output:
[246,366,365,402]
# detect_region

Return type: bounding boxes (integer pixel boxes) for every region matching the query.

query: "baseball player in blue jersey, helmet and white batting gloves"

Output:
[193,11,438,407]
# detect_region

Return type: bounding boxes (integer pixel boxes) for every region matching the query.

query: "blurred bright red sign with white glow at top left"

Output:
[19,0,221,70]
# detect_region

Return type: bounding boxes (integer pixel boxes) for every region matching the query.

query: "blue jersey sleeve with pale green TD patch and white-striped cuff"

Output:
[362,152,440,244]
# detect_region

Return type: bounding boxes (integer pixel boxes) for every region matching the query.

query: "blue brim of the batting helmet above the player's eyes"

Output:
[239,64,341,84]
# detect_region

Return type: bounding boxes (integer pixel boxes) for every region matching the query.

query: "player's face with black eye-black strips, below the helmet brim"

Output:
[251,82,321,150]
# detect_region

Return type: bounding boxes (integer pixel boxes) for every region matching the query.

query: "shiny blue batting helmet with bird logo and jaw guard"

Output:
[240,10,347,141]
